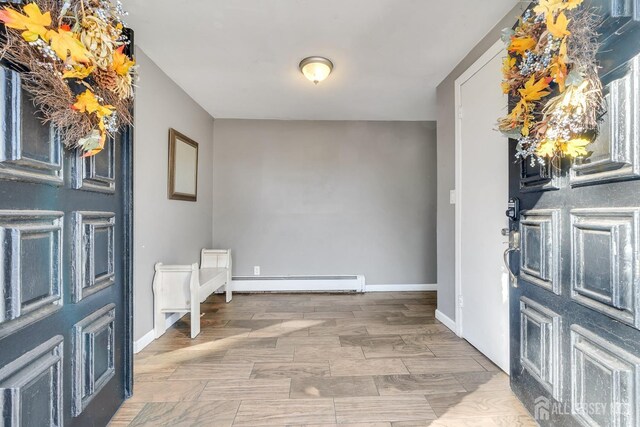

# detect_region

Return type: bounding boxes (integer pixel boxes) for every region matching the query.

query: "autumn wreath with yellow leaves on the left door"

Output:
[0,0,136,156]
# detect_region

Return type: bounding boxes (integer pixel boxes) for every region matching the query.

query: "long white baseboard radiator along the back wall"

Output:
[231,275,365,292]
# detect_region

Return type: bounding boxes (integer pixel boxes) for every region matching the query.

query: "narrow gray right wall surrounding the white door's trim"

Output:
[437,2,527,320]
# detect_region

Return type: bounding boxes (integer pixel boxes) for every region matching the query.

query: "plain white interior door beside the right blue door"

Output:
[456,42,509,372]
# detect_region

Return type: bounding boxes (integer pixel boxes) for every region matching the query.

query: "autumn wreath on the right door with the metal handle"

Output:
[498,0,605,164]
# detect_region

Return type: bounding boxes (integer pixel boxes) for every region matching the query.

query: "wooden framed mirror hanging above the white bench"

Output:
[169,129,198,202]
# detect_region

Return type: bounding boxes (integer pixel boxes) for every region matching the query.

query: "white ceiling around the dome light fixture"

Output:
[124,0,516,120]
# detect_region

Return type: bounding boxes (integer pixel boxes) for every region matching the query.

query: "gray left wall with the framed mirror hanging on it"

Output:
[133,48,213,340]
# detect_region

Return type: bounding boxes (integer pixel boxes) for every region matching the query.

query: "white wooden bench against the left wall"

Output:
[153,249,232,338]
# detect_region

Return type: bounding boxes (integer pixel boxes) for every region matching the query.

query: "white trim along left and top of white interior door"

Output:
[454,40,506,337]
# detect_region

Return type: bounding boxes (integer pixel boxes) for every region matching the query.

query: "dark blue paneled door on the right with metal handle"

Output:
[510,0,640,427]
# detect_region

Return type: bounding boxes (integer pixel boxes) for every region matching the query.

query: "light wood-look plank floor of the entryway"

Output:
[110,292,536,427]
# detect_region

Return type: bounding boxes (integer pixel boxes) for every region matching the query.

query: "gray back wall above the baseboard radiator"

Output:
[213,120,436,284]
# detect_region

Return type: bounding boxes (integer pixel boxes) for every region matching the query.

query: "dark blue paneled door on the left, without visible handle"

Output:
[0,61,131,427]
